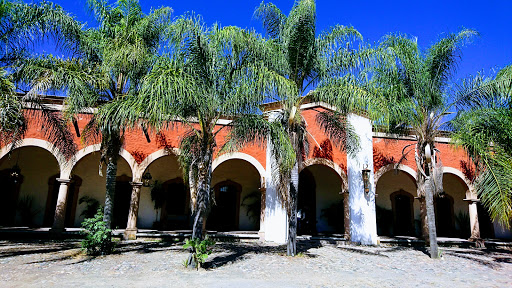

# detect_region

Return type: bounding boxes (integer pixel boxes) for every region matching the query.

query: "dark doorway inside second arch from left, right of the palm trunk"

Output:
[112,175,132,229]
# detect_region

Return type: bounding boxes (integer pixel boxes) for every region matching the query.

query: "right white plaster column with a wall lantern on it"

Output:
[347,114,377,245]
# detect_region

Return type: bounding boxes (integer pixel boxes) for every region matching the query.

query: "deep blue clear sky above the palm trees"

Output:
[31,0,512,78]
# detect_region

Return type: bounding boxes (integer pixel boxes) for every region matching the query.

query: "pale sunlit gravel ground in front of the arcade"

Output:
[0,241,512,288]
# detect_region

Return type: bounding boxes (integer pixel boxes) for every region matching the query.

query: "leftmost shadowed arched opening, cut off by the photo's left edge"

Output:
[0,146,60,227]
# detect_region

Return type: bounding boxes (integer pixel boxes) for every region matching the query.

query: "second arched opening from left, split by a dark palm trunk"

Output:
[71,152,132,228]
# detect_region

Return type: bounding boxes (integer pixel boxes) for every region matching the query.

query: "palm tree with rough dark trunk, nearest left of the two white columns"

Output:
[97,15,277,249]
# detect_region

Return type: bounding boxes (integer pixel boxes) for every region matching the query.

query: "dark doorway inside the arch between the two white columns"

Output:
[297,168,317,235]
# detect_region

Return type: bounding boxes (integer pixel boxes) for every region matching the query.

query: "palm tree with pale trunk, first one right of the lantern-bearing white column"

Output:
[372,29,477,258]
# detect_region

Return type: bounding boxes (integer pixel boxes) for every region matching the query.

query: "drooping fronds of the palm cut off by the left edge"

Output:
[0,0,77,159]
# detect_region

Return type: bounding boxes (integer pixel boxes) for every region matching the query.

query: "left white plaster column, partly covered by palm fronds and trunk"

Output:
[264,113,288,244]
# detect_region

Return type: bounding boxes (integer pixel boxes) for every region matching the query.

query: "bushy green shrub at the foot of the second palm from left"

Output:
[81,208,114,255]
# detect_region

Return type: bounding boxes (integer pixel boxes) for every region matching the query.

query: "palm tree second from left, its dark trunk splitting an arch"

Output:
[17,0,171,227]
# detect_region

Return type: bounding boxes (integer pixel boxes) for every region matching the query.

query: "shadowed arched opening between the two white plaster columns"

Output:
[297,164,345,235]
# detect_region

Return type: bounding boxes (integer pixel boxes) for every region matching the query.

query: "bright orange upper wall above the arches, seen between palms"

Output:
[17,107,469,176]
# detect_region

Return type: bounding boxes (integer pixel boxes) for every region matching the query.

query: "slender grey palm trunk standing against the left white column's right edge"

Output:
[286,164,299,256]
